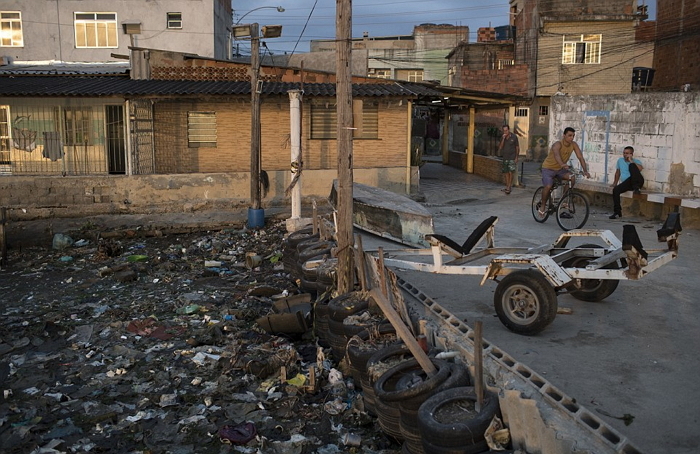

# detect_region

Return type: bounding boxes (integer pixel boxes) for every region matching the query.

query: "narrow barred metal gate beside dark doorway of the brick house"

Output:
[129,99,155,175]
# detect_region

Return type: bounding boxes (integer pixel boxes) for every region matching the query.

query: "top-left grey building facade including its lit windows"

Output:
[0,0,232,62]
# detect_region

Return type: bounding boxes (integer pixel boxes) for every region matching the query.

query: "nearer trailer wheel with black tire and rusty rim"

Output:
[494,270,557,335]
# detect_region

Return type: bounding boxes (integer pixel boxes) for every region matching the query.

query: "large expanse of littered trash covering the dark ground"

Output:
[0,224,401,454]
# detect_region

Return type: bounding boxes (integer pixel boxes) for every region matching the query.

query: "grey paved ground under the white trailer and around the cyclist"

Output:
[364,163,700,454]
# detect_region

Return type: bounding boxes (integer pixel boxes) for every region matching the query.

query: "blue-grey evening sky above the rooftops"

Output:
[231,0,656,55]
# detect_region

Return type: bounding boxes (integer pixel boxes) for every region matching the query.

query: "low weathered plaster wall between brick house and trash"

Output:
[0,167,419,220]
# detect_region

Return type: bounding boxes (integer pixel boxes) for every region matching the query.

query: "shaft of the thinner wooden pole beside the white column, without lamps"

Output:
[250,23,261,210]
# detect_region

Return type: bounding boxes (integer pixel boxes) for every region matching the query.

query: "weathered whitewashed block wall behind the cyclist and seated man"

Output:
[549,93,700,197]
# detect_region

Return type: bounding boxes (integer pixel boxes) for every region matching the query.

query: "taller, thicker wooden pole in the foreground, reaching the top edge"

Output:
[335,0,354,294]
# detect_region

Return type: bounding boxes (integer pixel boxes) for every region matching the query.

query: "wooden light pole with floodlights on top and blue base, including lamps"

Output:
[232,21,284,228]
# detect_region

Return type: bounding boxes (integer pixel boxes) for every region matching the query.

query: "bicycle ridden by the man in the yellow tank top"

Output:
[532,171,590,232]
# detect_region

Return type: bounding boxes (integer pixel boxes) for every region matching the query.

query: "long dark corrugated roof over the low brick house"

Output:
[0,76,441,98]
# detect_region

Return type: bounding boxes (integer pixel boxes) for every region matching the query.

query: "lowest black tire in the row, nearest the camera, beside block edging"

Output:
[418,386,499,448]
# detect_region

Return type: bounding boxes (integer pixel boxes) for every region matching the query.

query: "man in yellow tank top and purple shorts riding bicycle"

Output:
[537,127,591,217]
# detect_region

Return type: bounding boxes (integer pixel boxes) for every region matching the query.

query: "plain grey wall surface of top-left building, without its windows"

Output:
[0,0,231,61]
